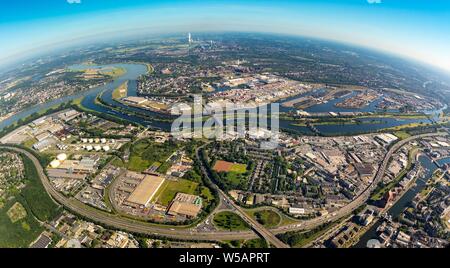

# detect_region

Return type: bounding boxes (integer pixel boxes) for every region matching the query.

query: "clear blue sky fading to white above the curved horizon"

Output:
[0,0,450,72]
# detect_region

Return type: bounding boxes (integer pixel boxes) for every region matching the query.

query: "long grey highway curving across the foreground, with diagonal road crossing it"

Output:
[2,133,445,245]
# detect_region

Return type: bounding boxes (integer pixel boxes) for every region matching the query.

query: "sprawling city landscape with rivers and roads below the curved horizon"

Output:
[0,33,450,248]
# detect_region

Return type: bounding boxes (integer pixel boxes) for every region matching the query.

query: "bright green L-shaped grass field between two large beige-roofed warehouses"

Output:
[155,179,198,206]
